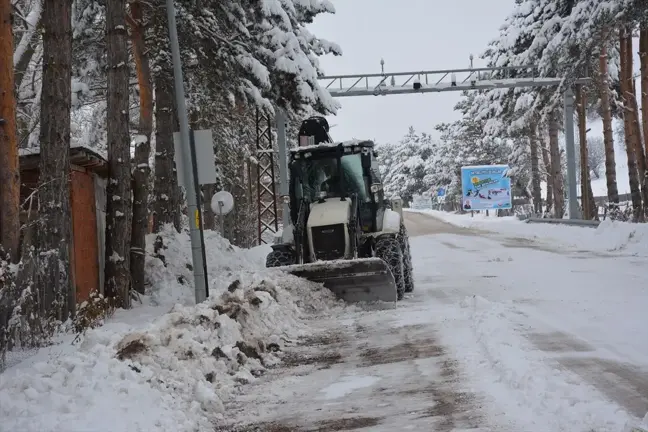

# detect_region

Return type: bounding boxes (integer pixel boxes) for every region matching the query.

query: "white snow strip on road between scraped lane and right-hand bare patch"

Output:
[460,296,631,432]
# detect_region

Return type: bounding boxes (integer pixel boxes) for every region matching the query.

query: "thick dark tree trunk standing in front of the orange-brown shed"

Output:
[36,0,74,319]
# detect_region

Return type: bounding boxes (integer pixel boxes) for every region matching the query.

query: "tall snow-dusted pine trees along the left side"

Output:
[0,0,341,362]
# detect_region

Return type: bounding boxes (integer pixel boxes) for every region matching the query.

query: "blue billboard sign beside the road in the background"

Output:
[461,165,513,210]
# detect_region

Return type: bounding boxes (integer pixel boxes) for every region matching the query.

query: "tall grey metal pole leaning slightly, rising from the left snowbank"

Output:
[166,0,208,303]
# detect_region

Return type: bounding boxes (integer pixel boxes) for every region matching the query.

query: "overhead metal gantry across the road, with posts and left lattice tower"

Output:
[257,59,591,242]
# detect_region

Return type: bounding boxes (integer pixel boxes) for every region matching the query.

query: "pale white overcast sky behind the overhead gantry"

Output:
[309,0,515,142]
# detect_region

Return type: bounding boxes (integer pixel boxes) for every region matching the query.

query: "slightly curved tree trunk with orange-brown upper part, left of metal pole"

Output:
[130,0,153,294]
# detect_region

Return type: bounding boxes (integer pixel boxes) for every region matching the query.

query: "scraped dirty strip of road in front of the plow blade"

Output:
[216,300,488,432]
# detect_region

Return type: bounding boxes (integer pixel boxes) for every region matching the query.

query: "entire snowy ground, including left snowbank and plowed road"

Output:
[0,212,648,432]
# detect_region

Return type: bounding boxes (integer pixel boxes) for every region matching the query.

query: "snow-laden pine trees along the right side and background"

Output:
[383,0,648,221]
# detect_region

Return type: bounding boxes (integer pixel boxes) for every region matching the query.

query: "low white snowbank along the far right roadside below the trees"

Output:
[410,210,648,256]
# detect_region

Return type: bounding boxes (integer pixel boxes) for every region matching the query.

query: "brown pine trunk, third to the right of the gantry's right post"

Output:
[619,28,643,221]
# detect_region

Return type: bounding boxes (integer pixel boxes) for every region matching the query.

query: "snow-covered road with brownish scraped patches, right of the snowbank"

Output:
[222,213,648,432]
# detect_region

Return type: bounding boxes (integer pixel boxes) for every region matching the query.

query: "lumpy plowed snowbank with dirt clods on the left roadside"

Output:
[0,226,334,432]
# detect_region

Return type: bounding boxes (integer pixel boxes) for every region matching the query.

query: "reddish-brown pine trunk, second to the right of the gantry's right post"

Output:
[598,41,619,208]
